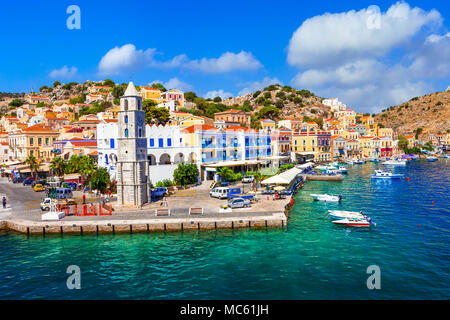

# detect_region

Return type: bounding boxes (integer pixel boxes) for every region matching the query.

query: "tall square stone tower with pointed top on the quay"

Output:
[117,82,149,207]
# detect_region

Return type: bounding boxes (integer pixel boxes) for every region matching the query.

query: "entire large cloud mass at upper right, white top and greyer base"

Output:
[288,2,450,112]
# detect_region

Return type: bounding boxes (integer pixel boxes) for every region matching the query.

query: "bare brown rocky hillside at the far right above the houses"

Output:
[375,91,450,137]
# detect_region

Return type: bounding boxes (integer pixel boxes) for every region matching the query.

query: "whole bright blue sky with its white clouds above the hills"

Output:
[0,0,450,112]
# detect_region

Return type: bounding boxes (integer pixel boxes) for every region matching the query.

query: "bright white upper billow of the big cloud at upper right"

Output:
[288,2,442,68]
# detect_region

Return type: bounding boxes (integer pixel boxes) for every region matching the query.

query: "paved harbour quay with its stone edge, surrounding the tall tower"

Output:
[0,179,289,234]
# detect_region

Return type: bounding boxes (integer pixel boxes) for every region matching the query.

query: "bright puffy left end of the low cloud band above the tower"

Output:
[98,44,156,75]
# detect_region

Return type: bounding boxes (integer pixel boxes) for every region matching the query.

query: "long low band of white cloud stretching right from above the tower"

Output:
[98,44,262,75]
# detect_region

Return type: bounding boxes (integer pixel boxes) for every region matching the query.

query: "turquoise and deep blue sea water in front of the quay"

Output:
[0,159,450,299]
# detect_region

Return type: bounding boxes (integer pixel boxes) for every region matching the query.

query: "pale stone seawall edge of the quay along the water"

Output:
[0,212,287,234]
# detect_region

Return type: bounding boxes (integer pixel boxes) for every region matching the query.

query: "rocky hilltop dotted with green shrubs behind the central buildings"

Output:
[222,85,331,119]
